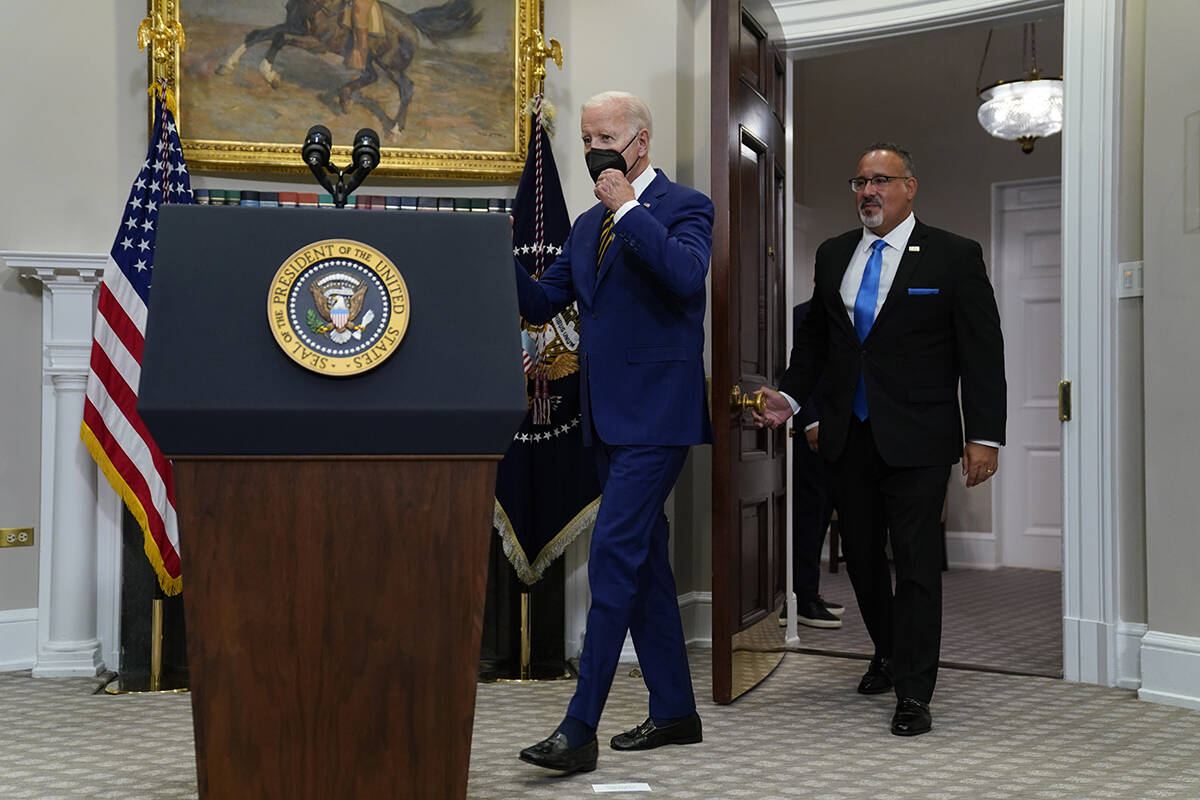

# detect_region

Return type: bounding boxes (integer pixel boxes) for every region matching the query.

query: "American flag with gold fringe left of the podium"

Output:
[79,95,192,595]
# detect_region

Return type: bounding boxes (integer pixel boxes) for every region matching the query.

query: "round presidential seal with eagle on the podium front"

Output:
[266,239,410,377]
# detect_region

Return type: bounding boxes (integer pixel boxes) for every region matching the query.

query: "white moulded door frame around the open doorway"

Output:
[773,0,1124,686]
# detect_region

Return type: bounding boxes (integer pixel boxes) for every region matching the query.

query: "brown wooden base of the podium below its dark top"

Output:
[174,455,499,800]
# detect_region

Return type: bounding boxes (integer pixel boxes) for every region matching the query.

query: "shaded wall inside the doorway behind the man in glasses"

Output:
[796,18,1062,531]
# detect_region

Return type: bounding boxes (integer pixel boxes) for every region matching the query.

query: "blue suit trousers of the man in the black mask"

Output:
[566,443,696,728]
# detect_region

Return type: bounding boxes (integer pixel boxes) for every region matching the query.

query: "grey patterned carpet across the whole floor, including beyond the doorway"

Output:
[0,571,1200,800]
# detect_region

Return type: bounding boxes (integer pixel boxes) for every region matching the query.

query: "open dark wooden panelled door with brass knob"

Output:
[712,0,788,703]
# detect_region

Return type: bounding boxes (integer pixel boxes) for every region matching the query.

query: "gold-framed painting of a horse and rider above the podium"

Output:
[149,0,542,181]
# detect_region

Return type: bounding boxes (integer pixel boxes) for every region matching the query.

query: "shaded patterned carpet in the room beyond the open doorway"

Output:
[796,567,1062,678]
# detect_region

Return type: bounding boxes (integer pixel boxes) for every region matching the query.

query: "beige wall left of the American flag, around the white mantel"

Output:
[0,0,145,610]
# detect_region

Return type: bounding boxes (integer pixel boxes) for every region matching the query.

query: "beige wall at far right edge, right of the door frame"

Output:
[1142,0,1200,637]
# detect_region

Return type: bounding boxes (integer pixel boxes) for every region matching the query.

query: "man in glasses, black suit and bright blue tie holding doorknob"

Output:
[755,143,1006,736]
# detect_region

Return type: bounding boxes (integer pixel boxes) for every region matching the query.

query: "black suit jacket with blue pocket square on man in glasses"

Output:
[779,221,1007,467]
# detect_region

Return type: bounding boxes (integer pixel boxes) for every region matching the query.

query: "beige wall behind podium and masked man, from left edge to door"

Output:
[0,0,709,610]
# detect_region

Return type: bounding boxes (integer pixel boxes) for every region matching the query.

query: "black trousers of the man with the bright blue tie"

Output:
[829,417,950,703]
